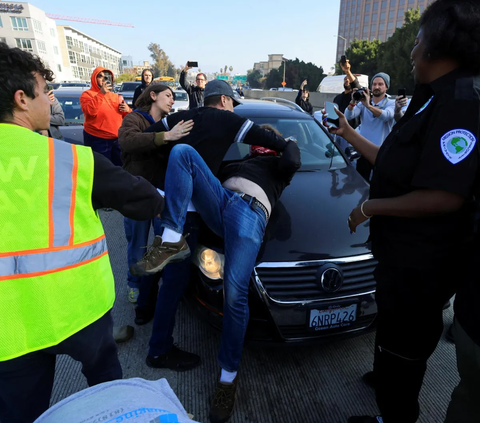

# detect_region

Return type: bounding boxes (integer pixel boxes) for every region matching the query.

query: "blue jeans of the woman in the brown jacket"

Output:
[123,217,162,306]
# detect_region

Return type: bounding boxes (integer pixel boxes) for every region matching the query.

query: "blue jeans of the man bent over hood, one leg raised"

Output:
[162,144,267,371]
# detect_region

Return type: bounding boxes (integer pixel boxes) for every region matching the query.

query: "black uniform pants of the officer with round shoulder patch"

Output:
[374,263,458,423]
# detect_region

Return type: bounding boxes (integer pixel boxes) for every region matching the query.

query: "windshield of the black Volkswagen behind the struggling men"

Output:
[244,118,347,171]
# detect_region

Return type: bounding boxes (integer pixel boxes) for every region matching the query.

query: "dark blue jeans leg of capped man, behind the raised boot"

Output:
[148,213,200,357]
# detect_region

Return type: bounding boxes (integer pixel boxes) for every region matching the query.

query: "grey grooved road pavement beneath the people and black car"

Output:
[52,211,458,423]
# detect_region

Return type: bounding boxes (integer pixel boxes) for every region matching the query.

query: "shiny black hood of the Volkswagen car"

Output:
[258,165,370,262]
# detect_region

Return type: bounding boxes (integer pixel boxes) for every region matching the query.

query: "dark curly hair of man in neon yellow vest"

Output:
[0,43,53,122]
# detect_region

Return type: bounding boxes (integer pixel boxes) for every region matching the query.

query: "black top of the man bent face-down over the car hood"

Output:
[219,141,301,210]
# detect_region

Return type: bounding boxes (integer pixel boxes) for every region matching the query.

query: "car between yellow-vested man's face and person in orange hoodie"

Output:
[53,87,89,144]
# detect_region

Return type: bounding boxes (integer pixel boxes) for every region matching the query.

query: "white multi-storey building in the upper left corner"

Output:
[0,2,122,82]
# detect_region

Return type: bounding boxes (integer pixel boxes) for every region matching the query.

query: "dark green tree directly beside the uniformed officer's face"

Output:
[372,9,420,94]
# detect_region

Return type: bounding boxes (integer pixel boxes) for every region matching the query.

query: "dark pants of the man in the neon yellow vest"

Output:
[0,312,122,423]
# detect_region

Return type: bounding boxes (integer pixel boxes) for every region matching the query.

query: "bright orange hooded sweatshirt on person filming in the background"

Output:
[80,66,128,139]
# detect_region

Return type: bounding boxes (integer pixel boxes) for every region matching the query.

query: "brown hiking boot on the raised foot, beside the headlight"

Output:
[130,235,190,276]
